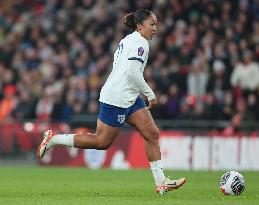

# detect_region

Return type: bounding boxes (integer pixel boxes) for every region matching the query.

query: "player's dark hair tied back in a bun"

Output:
[123,9,152,30]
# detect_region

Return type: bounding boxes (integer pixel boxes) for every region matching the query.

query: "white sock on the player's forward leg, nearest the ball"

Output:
[149,160,165,186]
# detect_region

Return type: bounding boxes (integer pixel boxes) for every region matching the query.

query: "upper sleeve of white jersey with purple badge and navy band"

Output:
[128,39,149,64]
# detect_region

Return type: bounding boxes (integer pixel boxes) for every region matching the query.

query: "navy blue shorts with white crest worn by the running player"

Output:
[98,96,146,127]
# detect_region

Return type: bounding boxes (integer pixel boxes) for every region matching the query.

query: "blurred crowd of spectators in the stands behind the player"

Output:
[0,0,259,121]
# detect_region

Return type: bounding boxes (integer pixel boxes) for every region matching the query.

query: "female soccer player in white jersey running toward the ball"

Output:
[38,10,186,194]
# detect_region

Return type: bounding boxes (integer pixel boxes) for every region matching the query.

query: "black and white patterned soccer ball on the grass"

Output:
[220,171,245,195]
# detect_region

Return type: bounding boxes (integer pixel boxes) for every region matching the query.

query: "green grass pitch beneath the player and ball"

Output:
[0,167,259,205]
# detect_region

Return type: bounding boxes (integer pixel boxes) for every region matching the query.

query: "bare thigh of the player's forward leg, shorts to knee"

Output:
[127,108,159,141]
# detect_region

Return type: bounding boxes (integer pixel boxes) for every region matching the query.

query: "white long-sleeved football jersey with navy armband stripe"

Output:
[99,31,155,108]
